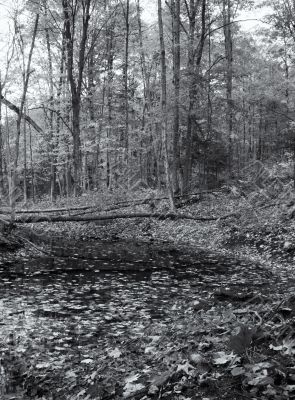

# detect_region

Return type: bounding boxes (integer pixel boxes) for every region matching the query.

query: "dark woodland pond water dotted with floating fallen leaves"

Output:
[0,240,280,398]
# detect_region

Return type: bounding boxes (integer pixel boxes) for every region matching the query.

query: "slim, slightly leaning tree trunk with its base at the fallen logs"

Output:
[158,0,175,211]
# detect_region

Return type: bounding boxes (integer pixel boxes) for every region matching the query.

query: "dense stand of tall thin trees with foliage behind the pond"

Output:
[0,0,295,207]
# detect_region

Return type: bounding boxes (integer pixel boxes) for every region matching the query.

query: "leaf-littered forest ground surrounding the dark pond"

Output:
[1,190,295,400]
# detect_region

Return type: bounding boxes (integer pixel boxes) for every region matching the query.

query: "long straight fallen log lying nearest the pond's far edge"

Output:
[14,213,238,224]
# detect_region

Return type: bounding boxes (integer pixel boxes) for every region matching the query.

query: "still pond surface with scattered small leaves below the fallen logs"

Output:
[0,240,267,343]
